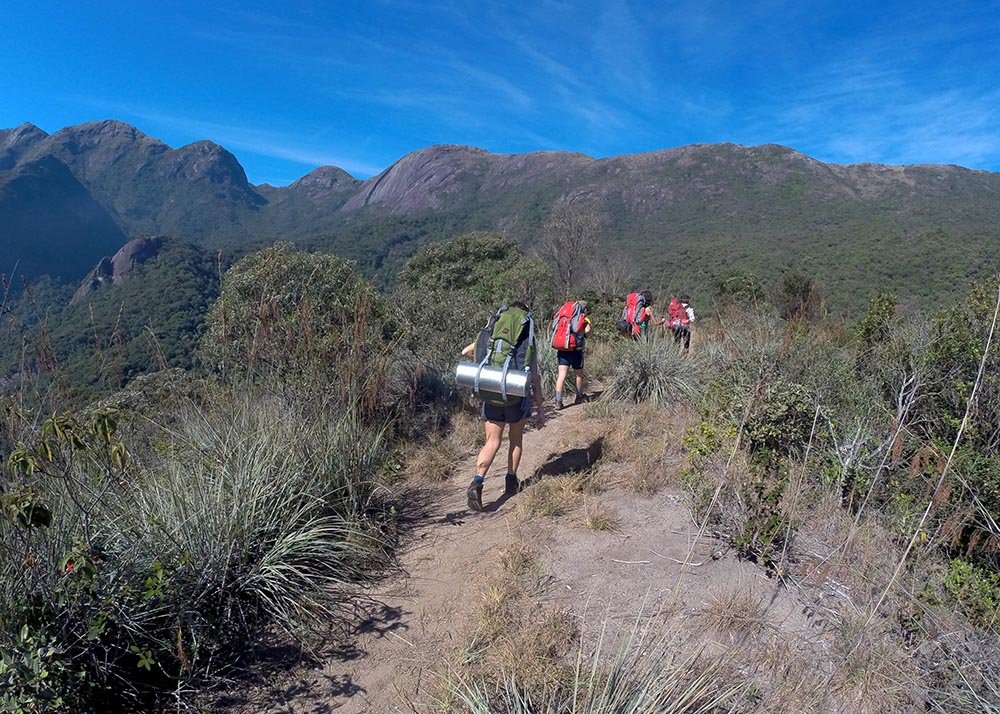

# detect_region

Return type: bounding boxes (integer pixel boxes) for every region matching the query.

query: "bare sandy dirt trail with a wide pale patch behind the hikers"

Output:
[245,400,805,714]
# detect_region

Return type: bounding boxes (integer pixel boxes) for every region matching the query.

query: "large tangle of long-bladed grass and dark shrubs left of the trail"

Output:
[0,392,387,711]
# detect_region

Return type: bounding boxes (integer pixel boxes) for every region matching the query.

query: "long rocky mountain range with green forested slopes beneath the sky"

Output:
[0,121,1000,305]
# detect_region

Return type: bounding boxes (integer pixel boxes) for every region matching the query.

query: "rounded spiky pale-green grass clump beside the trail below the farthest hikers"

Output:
[608,334,700,407]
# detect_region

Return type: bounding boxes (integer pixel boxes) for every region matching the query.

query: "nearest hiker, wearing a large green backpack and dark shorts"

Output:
[462,302,545,511]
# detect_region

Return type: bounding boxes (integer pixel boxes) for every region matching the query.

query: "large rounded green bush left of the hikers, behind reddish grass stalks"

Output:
[202,243,405,412]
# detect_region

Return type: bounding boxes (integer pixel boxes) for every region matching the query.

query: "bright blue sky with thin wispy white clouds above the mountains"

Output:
[0,0,1000,184]
